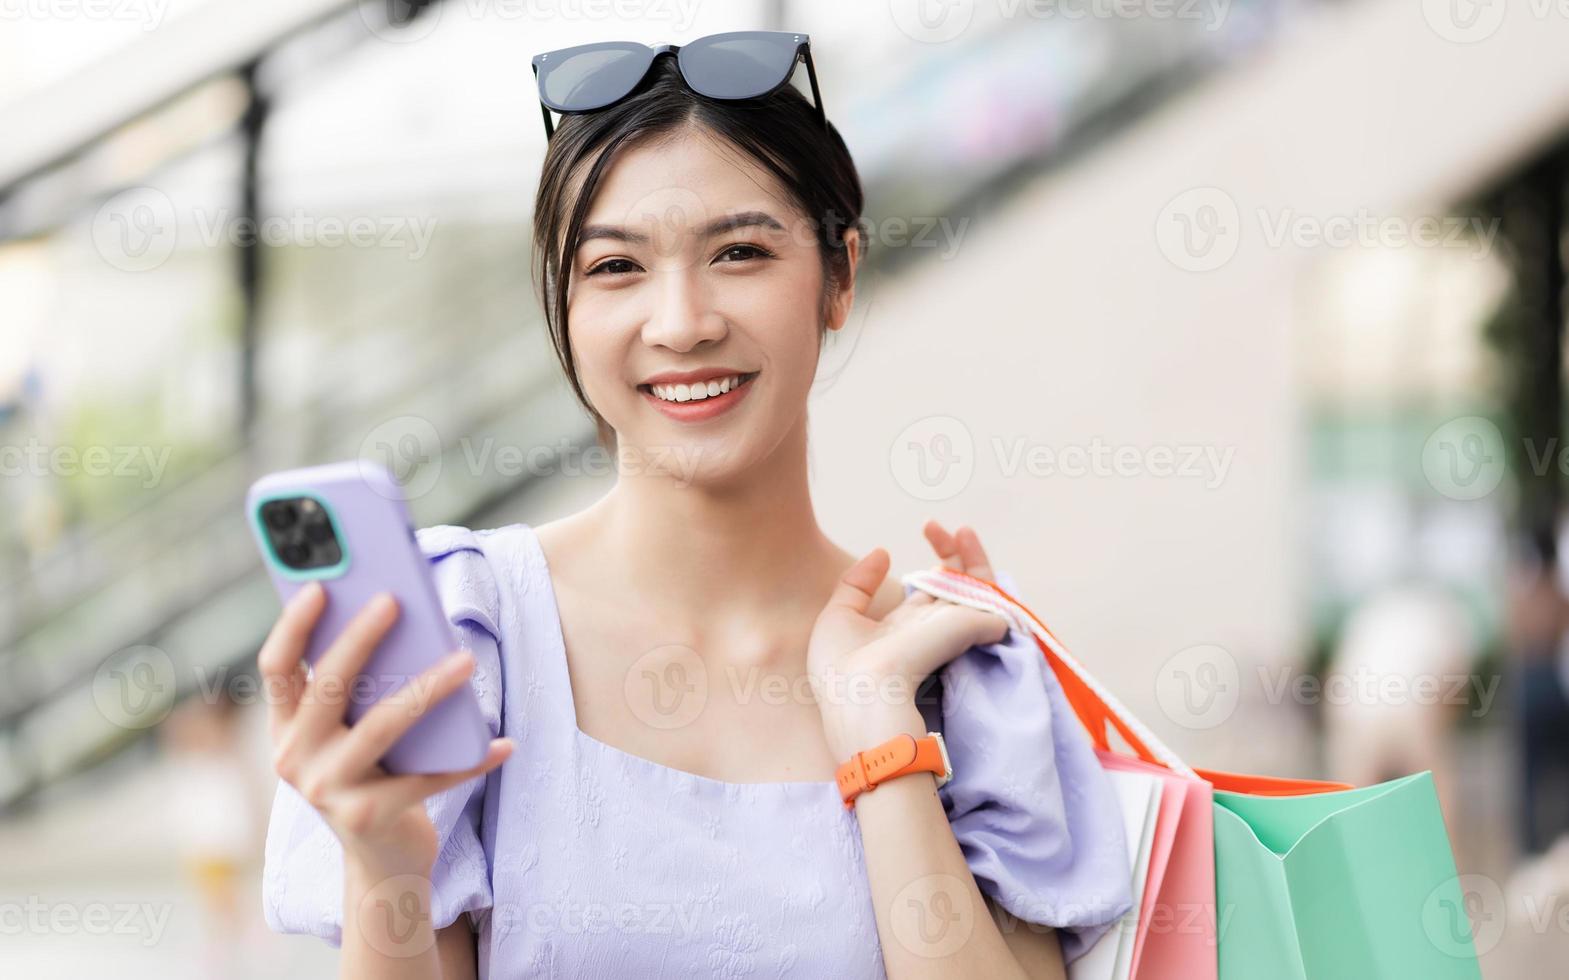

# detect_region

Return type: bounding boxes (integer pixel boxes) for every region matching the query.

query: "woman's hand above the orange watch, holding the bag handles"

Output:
[806,521,1007,762]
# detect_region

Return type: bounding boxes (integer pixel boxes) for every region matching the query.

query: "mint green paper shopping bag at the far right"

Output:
[1214,773,1481,980]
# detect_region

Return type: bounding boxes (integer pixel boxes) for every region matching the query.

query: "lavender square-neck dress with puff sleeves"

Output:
[262,524,1131,980]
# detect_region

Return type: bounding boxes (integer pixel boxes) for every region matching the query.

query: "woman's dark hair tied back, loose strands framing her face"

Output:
[533,56,865,445]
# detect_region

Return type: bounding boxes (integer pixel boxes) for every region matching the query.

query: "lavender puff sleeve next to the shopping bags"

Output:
[905,572,1133,961]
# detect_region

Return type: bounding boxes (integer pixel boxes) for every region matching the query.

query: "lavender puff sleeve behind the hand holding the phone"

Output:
[262,525,502,947]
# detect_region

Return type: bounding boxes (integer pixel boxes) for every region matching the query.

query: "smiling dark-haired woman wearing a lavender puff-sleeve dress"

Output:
[259,33,1130,980]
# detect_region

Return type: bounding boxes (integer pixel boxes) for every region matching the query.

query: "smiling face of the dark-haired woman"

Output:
[566,129,858,483]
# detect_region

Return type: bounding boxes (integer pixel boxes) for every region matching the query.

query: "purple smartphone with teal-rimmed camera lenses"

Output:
[245,461,490,773]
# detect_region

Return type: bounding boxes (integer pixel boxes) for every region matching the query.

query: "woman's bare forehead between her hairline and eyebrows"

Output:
[585,129,802,229]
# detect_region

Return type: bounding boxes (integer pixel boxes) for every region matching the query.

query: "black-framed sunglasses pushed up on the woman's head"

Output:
[533,31,827,140]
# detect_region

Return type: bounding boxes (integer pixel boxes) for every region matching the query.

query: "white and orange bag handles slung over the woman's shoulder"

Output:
[901,566,1200,779]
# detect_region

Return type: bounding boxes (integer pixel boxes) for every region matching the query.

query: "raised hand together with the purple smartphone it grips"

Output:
[246,463,511,873]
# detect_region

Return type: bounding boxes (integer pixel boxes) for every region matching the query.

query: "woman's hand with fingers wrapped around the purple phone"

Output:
[256,582,511,877]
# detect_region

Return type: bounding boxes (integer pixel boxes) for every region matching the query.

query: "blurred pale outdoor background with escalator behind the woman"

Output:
[0,0,1569,980]
